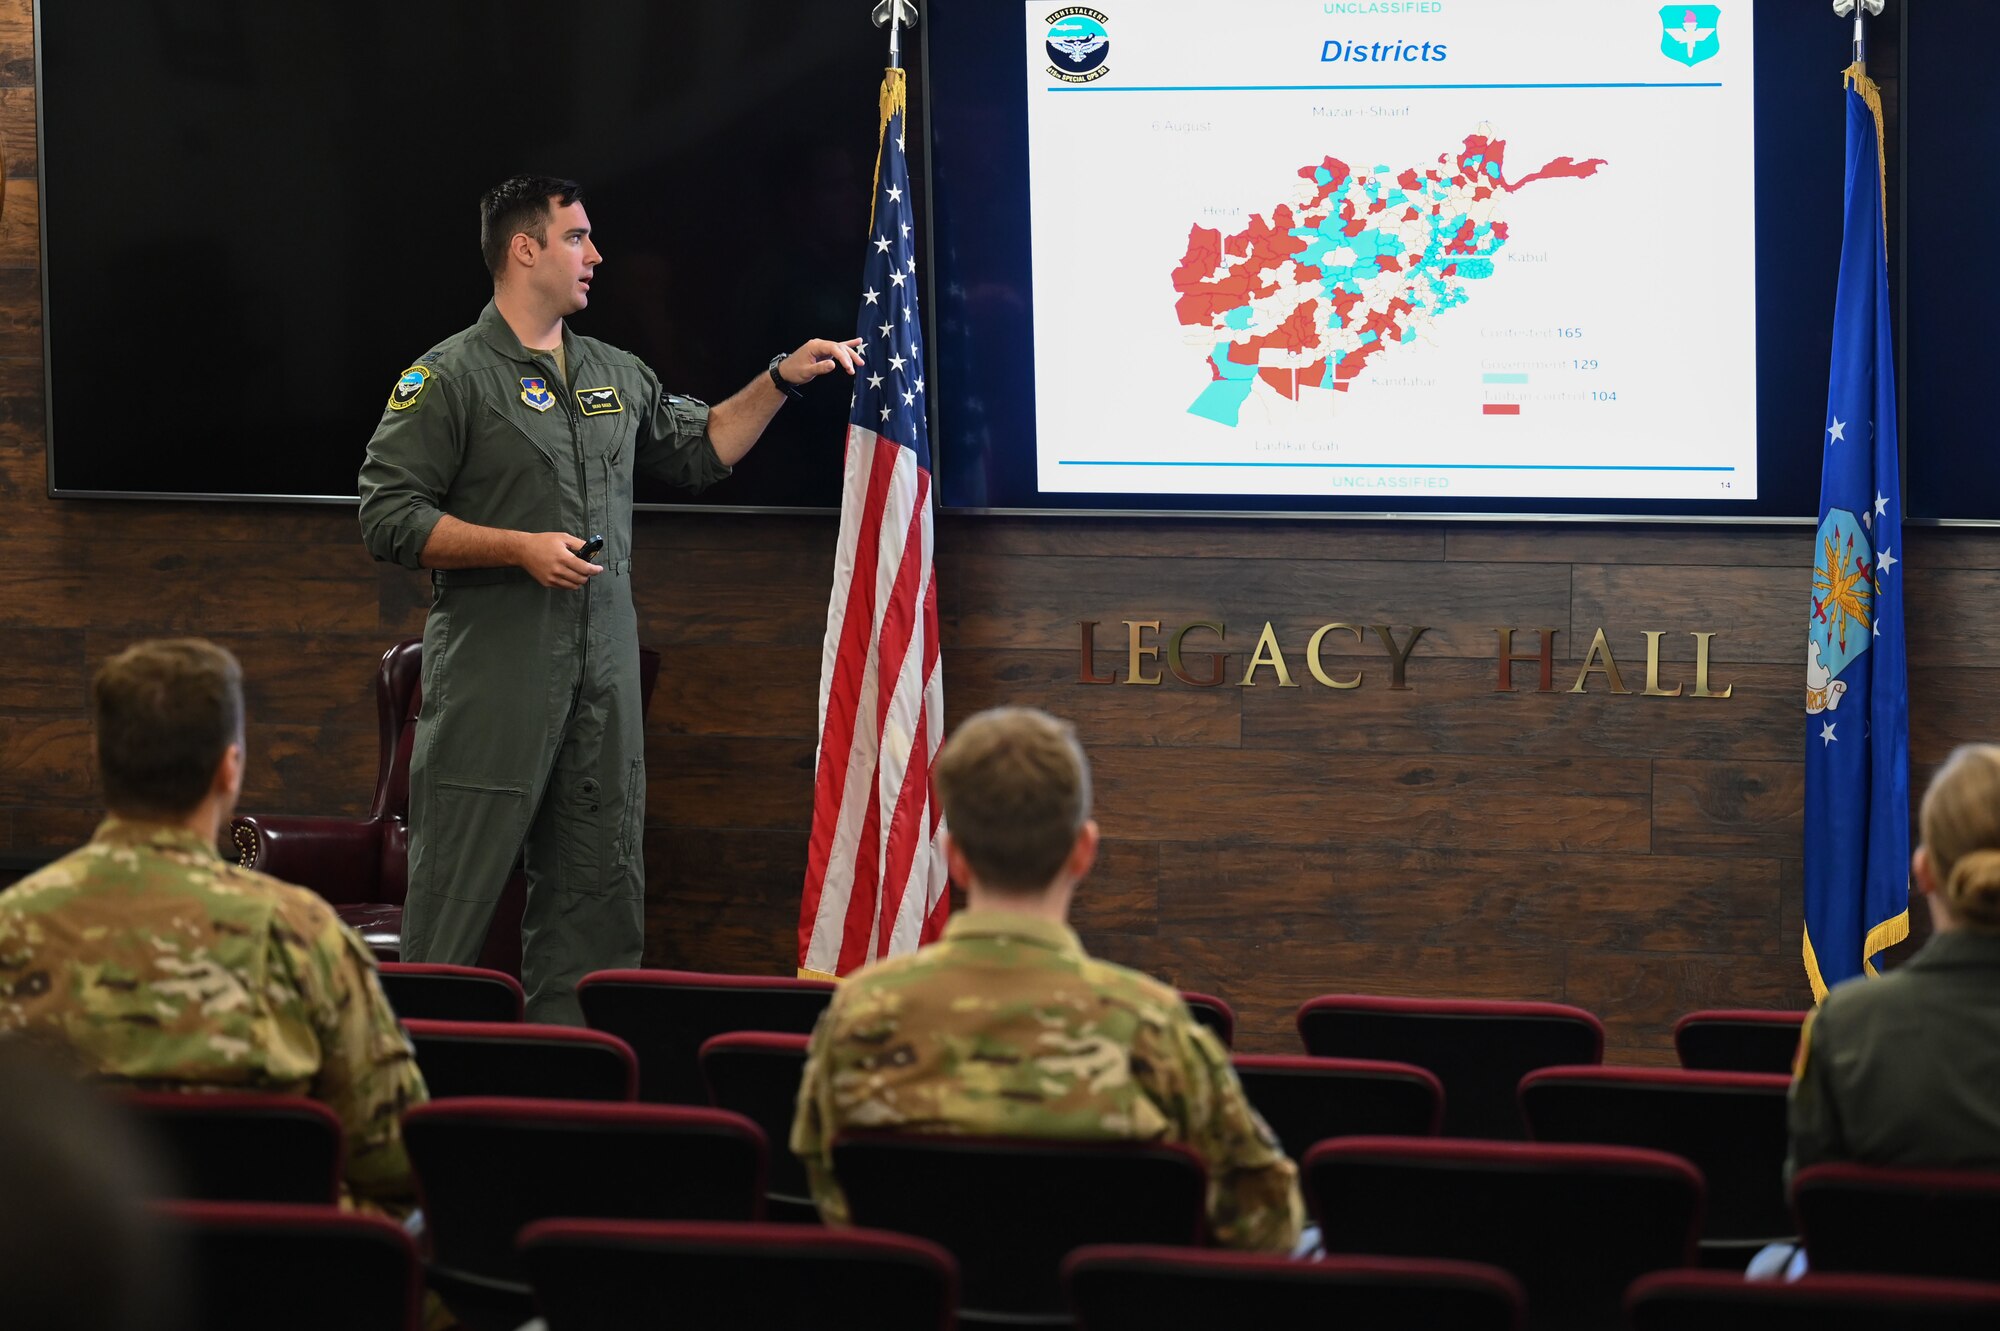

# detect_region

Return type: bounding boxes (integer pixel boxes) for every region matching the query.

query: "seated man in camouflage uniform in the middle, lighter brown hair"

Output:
[792,707,1302,1251]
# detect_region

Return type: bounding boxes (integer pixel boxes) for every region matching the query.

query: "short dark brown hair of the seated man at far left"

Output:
[90,638,244,817]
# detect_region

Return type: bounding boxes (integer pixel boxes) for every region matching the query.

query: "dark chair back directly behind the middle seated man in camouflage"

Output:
[834,1133,1208,1321]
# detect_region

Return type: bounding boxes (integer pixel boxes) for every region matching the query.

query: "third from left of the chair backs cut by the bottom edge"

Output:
[1062,1245,1526,1331]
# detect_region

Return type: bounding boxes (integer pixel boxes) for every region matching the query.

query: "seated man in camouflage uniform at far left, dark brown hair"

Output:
[0,640,426,1215]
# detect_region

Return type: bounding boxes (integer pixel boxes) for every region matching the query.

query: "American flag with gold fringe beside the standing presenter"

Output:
[798,68,950,977]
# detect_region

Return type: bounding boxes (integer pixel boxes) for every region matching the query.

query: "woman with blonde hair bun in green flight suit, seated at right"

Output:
[1786,743,2000,1177]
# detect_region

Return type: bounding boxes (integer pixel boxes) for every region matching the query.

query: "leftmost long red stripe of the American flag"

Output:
[798,426,900,965]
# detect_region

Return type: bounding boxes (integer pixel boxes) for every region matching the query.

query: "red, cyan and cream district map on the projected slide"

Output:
[1174,124,1604,426]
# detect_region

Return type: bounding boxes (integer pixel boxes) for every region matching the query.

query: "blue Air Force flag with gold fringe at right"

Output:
[1804,66,1910,1001]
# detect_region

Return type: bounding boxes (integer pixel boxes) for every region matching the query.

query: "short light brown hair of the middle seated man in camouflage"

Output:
[932,707,1090,893]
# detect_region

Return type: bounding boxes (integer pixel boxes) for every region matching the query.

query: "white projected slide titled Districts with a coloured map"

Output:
[1022,0,1758,502]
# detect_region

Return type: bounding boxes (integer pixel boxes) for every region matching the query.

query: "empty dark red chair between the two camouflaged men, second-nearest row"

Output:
[404,1099,764,1331]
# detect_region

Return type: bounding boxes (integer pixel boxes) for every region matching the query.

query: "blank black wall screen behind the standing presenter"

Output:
[36,0,916,506]
